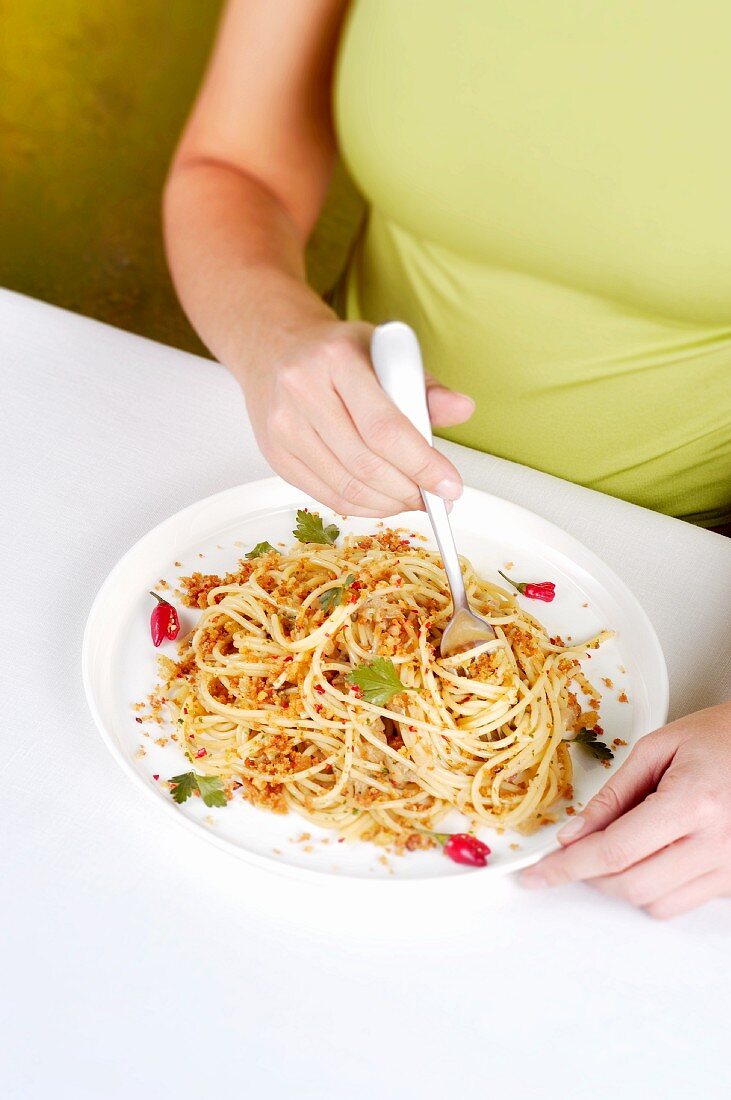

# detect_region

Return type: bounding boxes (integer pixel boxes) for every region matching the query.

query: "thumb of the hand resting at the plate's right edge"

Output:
[558,732,677,844]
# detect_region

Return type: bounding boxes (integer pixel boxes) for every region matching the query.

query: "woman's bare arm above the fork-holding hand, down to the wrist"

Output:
[164,0,345,365]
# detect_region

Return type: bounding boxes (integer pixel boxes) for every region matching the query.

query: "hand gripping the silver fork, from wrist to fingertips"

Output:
[240,317,475,516]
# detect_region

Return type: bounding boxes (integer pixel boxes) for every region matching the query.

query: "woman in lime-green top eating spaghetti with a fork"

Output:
[165,0,731,916]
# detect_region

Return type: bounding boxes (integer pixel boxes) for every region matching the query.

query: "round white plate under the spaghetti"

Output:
[82,477,668,882]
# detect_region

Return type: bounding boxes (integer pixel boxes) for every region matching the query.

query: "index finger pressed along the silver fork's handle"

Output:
[335,371,462,501]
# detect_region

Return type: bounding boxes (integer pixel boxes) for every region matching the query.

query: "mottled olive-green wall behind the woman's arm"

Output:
[0,0,362,351]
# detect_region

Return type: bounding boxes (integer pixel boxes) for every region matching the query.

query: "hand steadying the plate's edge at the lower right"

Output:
[521,702,731,919]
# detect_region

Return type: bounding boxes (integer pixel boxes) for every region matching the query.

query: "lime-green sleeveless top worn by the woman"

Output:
[334,0,731,526]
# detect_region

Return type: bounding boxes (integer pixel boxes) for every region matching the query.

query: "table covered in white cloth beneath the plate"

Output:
[0,292,731,1100]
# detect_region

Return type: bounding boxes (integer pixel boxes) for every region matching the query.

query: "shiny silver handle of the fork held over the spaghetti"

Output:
[370,321,469,612]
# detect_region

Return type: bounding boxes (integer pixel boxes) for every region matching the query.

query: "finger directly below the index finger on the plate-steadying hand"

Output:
[591,836,716,908]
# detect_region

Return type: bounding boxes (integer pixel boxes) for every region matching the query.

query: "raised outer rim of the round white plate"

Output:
[80,476,669,889]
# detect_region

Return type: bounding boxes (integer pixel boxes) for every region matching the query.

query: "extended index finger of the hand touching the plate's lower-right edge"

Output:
[521,792,693,888]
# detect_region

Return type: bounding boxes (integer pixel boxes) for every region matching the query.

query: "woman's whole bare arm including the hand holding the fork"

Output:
[164,0,474,515]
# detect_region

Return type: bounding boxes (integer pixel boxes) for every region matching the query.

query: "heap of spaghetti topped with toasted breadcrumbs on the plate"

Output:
[153,519,606,848]
